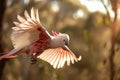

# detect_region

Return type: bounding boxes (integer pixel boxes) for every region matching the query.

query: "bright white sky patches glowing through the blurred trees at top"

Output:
[36,0,114,19]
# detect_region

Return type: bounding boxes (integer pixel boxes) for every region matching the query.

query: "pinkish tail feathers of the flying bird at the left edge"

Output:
[0,49,19,60]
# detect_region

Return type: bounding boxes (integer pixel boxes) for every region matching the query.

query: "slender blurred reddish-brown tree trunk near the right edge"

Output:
[109,0,120,80]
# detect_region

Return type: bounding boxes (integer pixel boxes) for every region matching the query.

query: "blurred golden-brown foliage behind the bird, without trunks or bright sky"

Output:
[2,0,120,80]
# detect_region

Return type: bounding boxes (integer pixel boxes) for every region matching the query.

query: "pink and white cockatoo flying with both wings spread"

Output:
[0,8,81,68]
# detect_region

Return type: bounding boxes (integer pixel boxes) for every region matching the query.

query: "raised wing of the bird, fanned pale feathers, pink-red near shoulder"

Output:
[11,8,50,49]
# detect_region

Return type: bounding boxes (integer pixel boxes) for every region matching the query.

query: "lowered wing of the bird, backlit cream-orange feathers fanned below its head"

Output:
[38,46,81,68]
